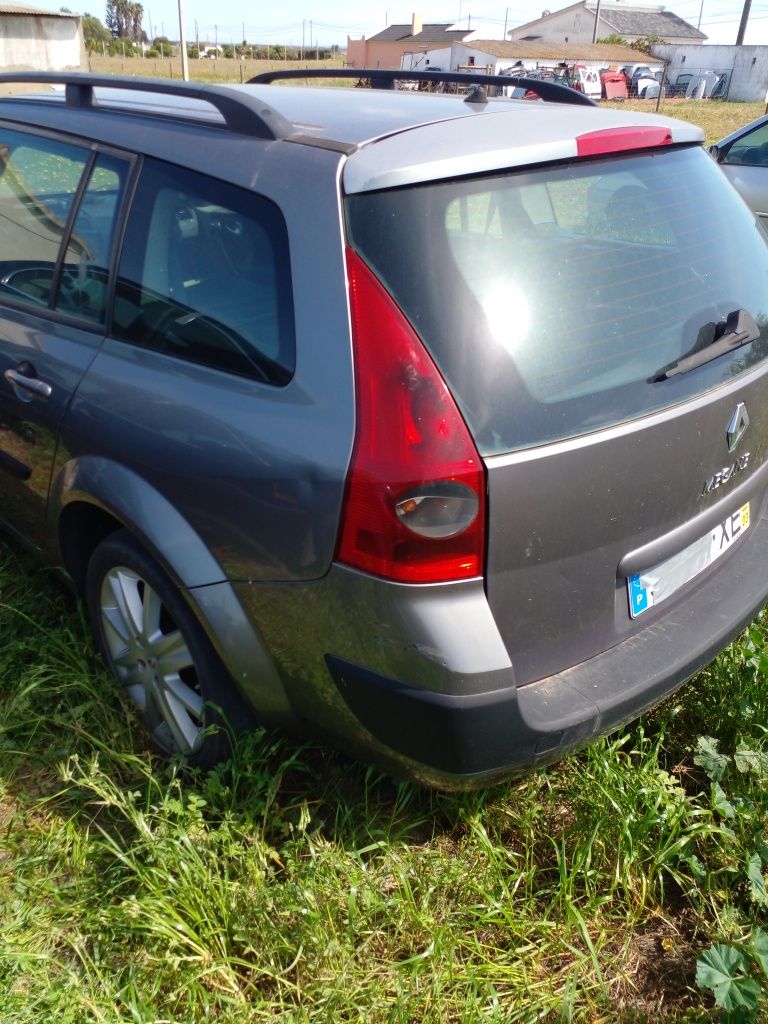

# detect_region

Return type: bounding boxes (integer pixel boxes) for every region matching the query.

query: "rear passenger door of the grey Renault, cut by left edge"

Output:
[0,127,130,547]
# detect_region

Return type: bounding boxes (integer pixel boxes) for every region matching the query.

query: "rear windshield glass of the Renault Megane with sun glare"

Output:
[346,146,768,455]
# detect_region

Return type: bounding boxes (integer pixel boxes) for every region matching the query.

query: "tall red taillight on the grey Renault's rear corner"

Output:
[338,249,485,583]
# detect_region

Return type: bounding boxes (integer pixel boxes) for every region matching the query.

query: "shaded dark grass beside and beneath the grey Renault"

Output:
[0,546,507,850]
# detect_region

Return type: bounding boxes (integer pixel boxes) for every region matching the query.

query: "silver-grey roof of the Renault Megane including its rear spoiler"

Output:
[0,76,703,193]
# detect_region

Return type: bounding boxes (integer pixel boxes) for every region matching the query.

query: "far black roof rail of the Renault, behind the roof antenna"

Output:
[249,68,597,106]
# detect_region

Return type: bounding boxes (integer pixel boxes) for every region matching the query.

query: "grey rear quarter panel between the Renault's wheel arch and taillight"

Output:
[57,139,354,586]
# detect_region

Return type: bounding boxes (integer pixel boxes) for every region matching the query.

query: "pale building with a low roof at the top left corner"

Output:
[0,5,85,71]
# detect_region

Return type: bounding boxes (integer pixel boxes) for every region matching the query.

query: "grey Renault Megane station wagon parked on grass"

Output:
[0,74,768,785]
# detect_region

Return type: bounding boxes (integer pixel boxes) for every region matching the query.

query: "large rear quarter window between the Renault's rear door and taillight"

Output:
[113,160,295,385]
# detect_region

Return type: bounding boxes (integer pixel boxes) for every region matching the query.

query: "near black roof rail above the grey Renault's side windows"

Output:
[0,71,294,139]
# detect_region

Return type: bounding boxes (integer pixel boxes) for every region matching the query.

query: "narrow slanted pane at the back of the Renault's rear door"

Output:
[55,156,127,323]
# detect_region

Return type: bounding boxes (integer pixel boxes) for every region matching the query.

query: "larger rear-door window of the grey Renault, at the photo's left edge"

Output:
[0,128,90,306]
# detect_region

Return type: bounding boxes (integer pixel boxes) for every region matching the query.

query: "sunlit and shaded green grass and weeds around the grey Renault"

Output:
[0,88,768,1024]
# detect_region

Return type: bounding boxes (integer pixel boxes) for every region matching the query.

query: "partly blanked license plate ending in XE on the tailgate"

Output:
[627,502,750,618]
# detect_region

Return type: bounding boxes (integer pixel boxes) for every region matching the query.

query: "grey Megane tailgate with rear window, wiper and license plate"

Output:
[348,136,768,683]
